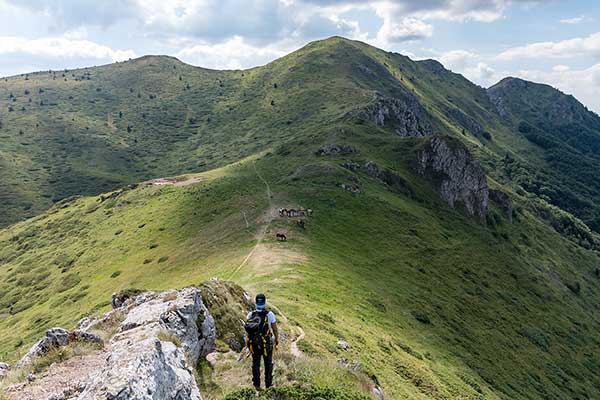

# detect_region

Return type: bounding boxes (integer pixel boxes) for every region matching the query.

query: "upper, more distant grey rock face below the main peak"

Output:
[358,92,432,137]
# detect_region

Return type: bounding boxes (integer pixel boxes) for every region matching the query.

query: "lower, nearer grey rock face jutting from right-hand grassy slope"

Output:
[416,136,489,220]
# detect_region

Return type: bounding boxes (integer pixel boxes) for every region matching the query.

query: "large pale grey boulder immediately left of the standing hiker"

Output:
[78,288,215,400]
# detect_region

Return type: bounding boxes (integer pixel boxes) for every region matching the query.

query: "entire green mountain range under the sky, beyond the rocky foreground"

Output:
[0,37,600,399]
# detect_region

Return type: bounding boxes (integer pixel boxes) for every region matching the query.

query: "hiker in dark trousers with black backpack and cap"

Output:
[245,293,279,390]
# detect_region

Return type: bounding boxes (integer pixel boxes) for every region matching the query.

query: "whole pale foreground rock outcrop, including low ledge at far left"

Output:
[11,288,216,400]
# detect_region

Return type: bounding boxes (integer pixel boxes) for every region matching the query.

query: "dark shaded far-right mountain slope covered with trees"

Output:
[488,78,600,231]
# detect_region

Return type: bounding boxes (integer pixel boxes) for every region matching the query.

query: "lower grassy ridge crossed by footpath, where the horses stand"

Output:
[0,127,600,399]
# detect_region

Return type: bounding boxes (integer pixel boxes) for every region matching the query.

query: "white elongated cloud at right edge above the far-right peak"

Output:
[498,32,600,61]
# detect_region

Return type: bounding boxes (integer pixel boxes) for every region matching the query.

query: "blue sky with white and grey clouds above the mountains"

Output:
[0,0,600,113]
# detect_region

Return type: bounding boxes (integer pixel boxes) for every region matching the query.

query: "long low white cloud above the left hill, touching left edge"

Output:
[0,36,135,62]
